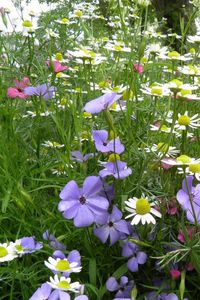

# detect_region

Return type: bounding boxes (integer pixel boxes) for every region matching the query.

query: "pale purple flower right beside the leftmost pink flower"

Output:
[24,83,55,100]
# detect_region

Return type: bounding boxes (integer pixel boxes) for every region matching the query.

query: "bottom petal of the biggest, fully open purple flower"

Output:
[74,205,94,227]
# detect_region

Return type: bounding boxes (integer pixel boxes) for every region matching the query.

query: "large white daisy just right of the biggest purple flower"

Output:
[125,197,161,225]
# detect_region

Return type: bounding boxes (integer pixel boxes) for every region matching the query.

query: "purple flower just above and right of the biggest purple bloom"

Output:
[99,160,132,179]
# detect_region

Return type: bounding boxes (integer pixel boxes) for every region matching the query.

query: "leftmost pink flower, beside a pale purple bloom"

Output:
[7,77,30,99]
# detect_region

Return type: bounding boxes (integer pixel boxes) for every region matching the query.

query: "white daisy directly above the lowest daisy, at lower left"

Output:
[44,257,82,273]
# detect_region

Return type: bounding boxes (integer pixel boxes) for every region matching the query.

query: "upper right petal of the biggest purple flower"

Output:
[83,176,103,198]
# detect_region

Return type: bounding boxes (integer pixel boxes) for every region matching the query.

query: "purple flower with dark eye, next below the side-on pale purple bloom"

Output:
[92,130,124,154]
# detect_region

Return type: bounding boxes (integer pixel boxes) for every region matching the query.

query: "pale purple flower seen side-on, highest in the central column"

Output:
[83,93,122,114]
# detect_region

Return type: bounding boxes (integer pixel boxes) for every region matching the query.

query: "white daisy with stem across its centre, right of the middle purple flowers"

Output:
[144,142,180,157]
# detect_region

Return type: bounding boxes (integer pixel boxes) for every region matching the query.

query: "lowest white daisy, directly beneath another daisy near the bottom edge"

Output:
[47,275,81,293]
